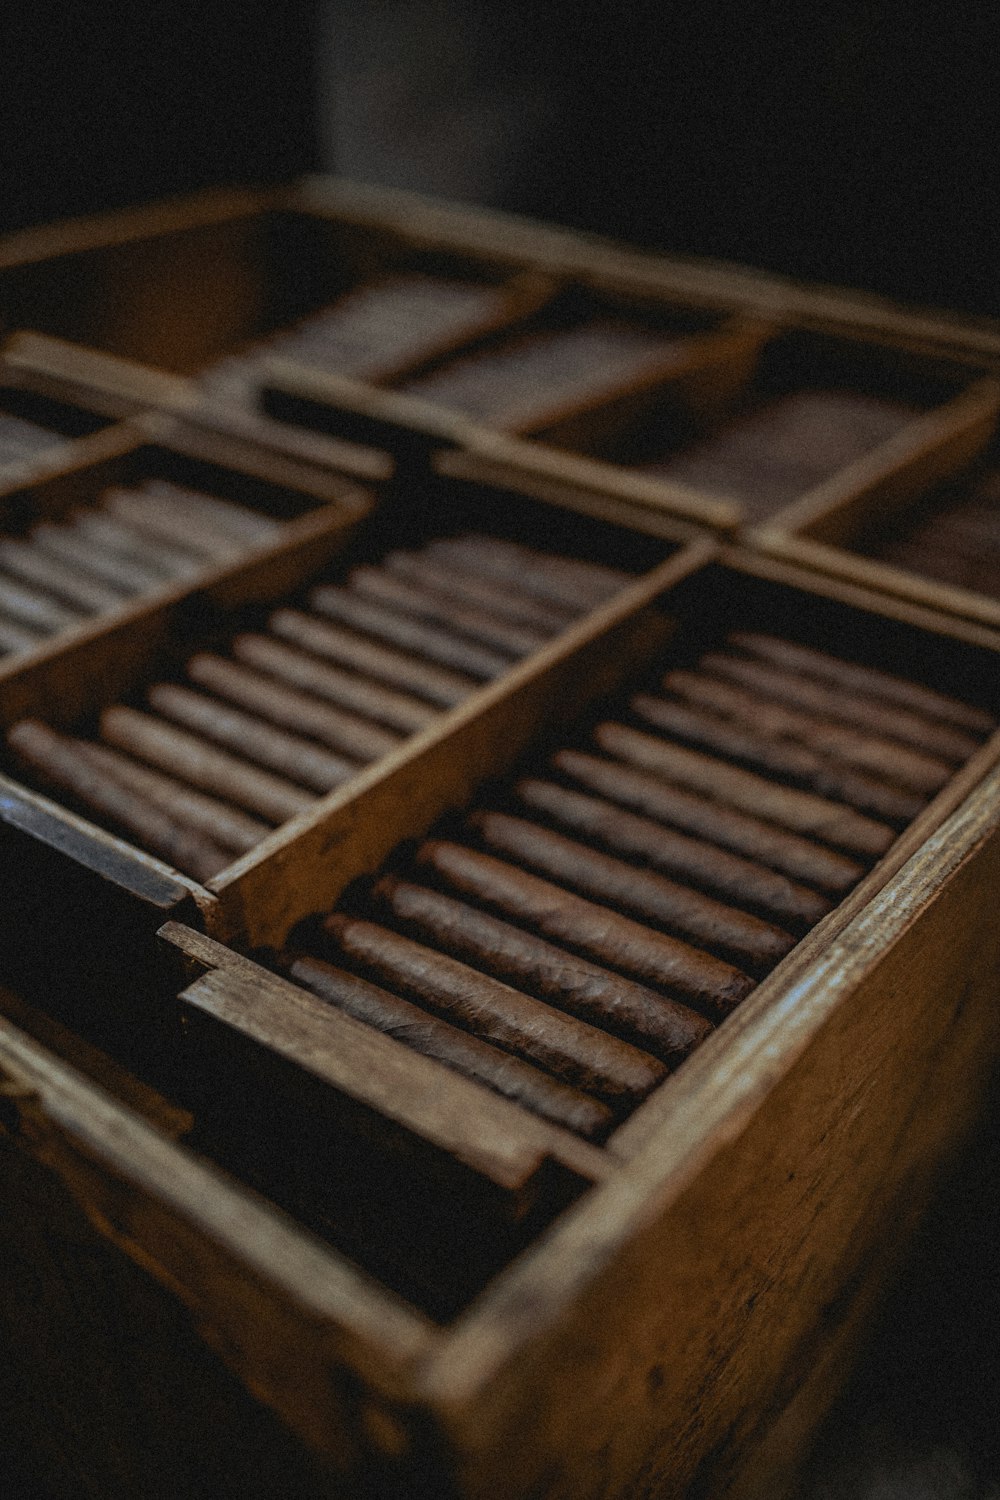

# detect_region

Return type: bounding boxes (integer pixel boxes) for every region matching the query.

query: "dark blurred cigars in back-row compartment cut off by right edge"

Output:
[865,468,1000,599]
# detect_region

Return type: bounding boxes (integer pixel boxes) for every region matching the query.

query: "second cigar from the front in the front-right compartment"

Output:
[322,912,667,1112]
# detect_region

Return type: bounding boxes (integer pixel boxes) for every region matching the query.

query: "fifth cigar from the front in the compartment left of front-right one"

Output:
[187,653,402,762]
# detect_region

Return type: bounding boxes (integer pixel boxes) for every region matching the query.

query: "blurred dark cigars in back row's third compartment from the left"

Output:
[643,390,919,521]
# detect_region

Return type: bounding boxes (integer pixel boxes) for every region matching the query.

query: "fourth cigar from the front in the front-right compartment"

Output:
[417,839,754,1020]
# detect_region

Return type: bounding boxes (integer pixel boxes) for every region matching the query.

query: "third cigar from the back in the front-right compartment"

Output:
[663,672,959,795]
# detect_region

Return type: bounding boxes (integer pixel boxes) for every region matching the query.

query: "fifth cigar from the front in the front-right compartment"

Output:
[468,812,795,977]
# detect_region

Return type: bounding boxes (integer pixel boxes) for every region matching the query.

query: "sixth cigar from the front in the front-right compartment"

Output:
[514,780,831,932]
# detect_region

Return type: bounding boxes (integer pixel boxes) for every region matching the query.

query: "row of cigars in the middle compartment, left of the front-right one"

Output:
[7,533,627,881]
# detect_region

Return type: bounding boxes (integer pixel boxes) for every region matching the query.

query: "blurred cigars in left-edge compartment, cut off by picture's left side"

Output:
[0,480,280,653]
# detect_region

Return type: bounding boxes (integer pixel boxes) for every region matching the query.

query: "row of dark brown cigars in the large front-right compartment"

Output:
[276,633,996,1140]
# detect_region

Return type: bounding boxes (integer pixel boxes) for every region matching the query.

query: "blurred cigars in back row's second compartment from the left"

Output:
[402,318,695,432]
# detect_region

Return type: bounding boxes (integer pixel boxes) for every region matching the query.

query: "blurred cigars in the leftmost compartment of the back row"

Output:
[204,275,507,401]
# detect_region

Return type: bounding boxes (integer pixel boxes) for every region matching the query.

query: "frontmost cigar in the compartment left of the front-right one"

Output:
[7,719,229,881]
